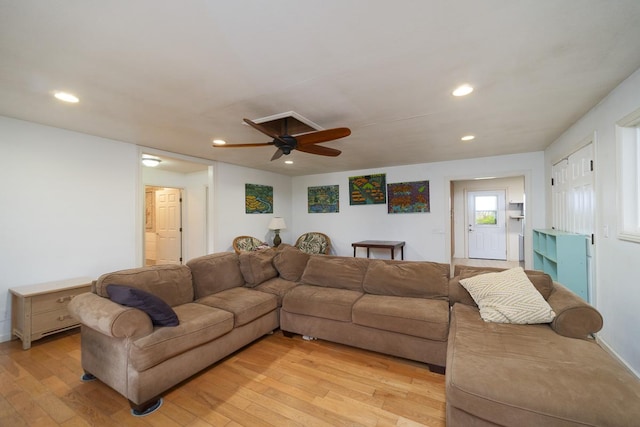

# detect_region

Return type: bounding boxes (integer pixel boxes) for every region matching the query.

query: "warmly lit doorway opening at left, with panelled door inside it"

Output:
[144,185,182,266]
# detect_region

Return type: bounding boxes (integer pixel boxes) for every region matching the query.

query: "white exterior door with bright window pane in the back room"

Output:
[467,191,507,260]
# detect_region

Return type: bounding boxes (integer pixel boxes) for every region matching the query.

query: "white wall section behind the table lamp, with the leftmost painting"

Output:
[213,163,296,252]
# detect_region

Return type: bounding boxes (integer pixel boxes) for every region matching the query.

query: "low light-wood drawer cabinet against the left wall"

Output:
[9,277,92,350]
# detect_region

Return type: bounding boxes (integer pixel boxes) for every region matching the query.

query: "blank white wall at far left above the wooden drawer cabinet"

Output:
[0,117,139,341]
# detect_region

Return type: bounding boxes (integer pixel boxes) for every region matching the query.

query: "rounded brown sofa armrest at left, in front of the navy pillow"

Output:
[68,292,153,338]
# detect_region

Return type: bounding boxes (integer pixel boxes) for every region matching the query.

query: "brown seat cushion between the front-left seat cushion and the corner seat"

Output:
[196,288,278,326]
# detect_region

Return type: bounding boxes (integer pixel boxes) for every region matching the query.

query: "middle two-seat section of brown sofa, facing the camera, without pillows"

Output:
[280,252,449,367]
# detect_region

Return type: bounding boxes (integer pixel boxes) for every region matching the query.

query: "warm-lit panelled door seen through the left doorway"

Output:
[156,188,182,264]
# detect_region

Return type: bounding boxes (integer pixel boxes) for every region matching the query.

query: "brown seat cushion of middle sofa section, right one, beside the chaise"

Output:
[353,295,449,341]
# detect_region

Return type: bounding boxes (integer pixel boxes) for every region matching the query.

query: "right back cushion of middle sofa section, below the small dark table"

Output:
[363,260,449,298]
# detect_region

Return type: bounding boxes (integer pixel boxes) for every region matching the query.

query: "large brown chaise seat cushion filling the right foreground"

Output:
[446,304,640,426]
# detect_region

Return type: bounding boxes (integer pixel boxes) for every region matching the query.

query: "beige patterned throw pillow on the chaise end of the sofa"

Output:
[460,267,556,324]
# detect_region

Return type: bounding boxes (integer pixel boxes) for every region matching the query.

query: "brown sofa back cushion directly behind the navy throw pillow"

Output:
[95,264,194,307]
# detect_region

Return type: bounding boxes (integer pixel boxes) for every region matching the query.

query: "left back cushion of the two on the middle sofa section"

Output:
[300,255,370,291]
